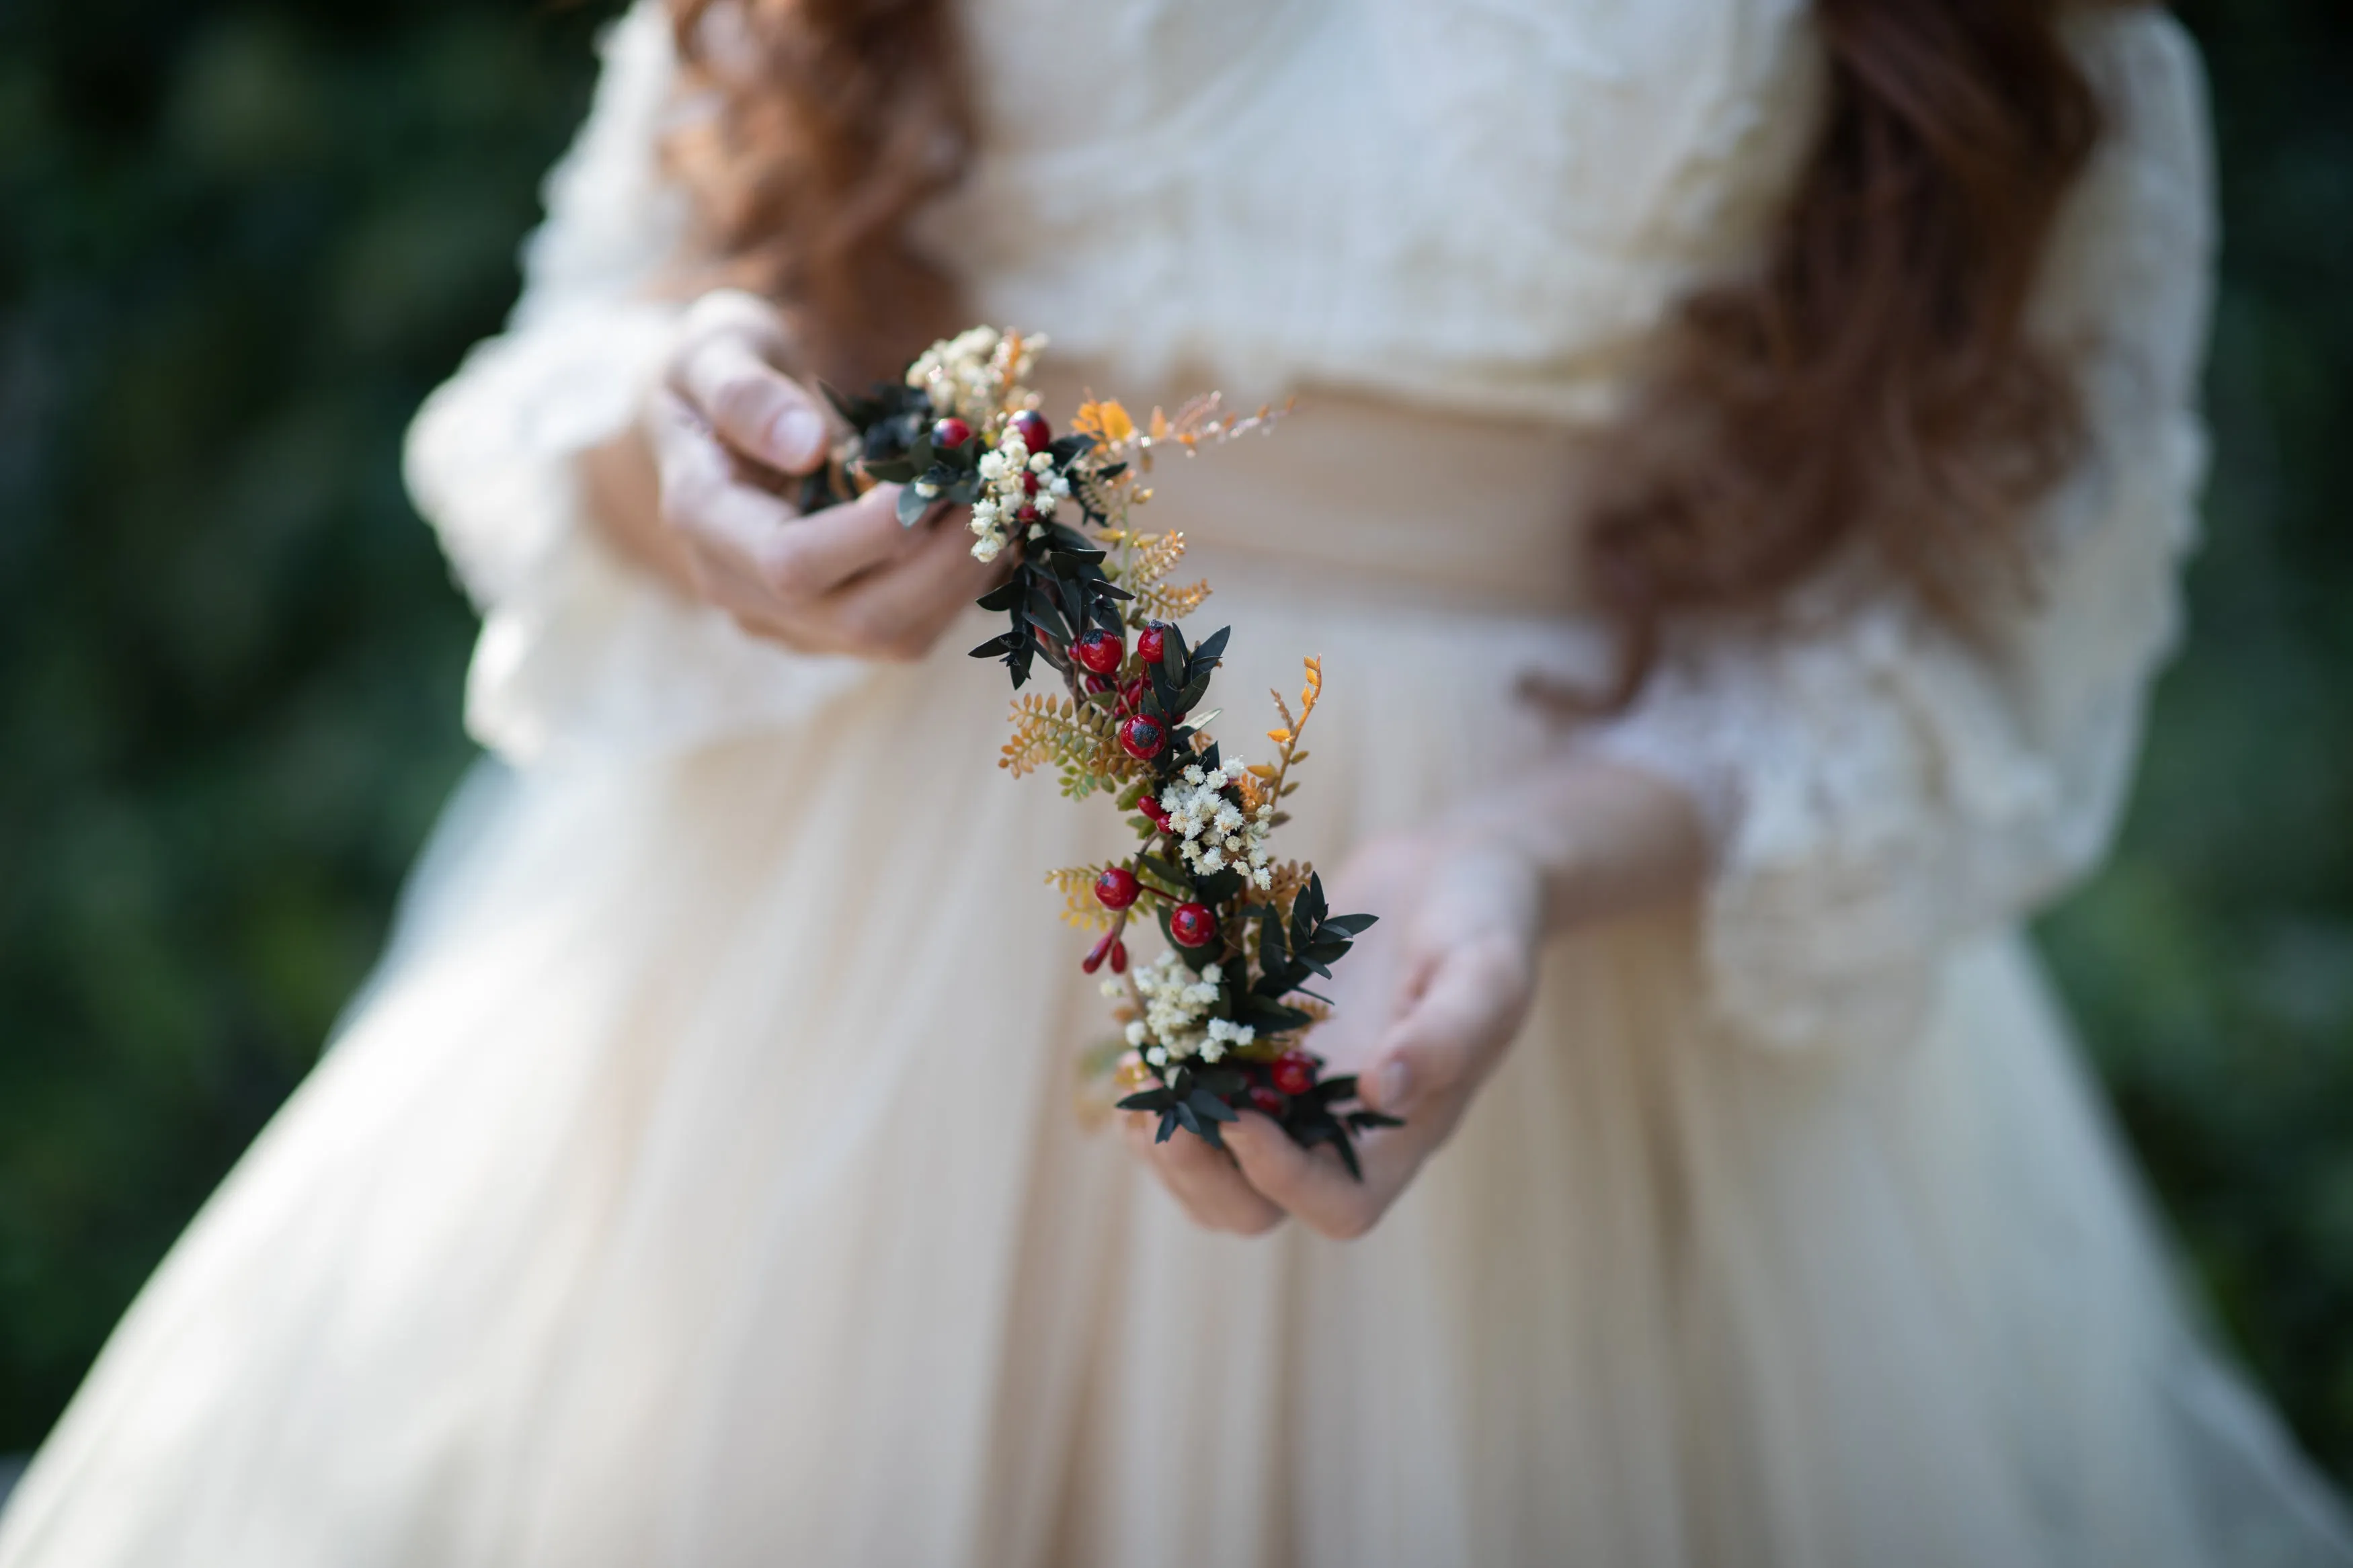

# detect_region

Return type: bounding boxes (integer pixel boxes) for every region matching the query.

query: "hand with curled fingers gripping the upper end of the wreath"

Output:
[633,289,1007,661]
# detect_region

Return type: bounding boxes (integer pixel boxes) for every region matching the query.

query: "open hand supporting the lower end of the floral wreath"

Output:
[1125,835,1544,1239]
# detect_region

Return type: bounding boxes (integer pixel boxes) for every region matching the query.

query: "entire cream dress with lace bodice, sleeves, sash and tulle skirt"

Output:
[0,0,2348,1568]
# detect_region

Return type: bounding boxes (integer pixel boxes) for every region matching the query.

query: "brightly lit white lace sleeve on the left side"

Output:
[407,0,866,761]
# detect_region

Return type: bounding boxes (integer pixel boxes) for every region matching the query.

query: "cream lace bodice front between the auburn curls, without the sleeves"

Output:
[927,0,1819,416]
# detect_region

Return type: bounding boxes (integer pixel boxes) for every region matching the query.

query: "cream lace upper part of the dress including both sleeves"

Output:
[409,0,2212,1044]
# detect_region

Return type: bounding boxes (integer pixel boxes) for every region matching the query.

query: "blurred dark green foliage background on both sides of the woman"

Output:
[0,0,2353,1481]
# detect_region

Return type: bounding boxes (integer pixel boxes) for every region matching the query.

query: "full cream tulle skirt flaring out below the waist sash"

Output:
[0,573,2344,1568]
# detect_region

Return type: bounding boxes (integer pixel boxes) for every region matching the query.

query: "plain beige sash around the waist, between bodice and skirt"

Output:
[1038,369,1589,614]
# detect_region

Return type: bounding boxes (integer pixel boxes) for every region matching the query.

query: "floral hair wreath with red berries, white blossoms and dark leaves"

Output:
[803,327,1396,1173]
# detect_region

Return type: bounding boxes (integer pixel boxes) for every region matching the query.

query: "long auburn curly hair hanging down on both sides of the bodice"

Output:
[671,0,2102,703]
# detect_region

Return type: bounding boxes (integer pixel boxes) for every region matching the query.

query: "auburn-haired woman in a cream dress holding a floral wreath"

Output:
[0,0,2353,1568]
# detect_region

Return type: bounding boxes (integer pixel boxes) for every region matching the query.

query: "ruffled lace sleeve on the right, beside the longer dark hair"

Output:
[1589,14,2215,1046]
